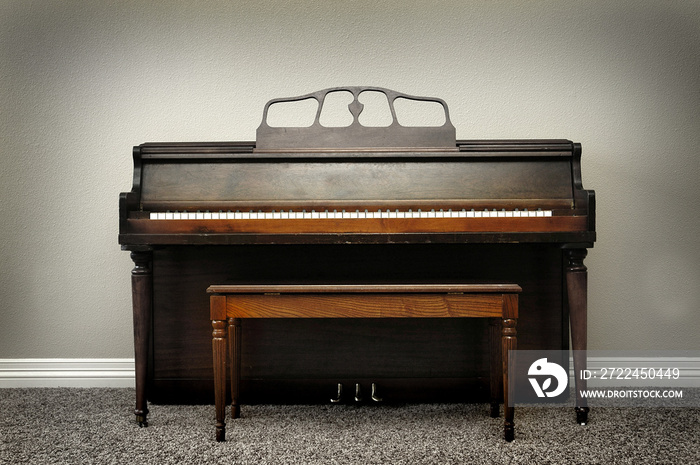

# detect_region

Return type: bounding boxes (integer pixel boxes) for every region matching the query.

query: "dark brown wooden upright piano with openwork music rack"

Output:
[119,87,596,425]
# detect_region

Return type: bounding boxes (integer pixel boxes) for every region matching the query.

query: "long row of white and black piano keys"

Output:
[149,209,552,220]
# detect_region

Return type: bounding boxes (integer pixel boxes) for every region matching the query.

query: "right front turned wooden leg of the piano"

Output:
[566,249,589,425]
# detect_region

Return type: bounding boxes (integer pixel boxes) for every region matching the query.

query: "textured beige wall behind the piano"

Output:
[0,0,700,358]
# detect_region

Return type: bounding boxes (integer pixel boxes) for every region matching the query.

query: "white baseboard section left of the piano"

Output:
[0,358,135,388]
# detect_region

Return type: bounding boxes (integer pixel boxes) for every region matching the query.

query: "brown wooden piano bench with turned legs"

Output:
[207,284,521,441]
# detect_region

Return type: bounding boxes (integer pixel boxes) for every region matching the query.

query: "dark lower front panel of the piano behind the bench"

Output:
[149,244,568,403]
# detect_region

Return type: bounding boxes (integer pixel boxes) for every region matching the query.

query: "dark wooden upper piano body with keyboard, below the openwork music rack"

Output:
[119,140,595,248]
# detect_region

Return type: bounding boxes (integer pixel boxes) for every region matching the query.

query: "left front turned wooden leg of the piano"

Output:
[131,251,153,426]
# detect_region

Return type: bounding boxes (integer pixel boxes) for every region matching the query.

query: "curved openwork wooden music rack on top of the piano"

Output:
[255,87,457,152]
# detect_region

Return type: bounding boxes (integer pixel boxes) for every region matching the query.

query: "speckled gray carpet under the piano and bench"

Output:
[0,388,700,464]
